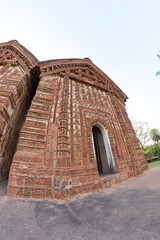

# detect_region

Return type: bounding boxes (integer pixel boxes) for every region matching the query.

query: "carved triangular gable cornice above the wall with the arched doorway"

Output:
[39,58,128,102]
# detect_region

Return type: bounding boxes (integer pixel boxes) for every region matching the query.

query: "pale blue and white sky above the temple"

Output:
[0,0,160,129]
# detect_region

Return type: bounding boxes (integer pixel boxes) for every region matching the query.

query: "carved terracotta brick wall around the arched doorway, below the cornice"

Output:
[8,66,147,199]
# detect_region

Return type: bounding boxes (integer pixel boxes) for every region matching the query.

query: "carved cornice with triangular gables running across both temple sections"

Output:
[0,40,128,103]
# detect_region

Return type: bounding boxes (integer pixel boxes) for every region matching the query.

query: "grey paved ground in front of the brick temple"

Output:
[0,165,160,240]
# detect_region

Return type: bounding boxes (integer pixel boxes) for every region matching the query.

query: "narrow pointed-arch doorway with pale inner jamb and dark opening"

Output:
[92,123,116,175]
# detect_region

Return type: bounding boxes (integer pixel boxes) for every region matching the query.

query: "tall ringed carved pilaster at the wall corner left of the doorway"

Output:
[53,76,72,198]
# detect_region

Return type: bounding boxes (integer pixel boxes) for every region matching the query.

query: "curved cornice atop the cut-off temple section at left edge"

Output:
[0,40,38,72]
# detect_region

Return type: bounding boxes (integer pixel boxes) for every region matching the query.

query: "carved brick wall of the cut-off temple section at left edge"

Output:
[0,41,38,181]
